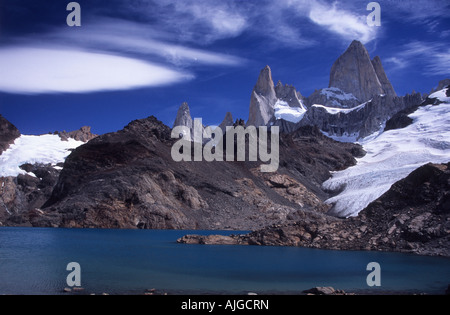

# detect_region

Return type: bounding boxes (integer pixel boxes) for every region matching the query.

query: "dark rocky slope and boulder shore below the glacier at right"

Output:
[180,163,450,257]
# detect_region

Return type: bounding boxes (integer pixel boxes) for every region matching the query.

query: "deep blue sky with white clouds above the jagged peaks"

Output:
[0,0,450,134]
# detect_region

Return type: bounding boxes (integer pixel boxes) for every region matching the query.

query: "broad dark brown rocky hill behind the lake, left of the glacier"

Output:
[32,117,360,229]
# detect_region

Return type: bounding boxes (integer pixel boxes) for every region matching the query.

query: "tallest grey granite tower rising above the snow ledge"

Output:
[329,41,395,103]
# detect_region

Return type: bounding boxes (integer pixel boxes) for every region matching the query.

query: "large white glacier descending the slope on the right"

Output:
[323,91,450,217]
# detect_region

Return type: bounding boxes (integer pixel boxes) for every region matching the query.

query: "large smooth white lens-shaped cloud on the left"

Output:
[0,47,192,94]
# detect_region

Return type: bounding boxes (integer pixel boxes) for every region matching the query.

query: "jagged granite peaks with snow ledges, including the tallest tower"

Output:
[243,41,423,139]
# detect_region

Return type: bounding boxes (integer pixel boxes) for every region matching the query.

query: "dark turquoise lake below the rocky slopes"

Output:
[0,227,450,294]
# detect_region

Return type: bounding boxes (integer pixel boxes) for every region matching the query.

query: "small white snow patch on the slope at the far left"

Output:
[0,135,84,177]
